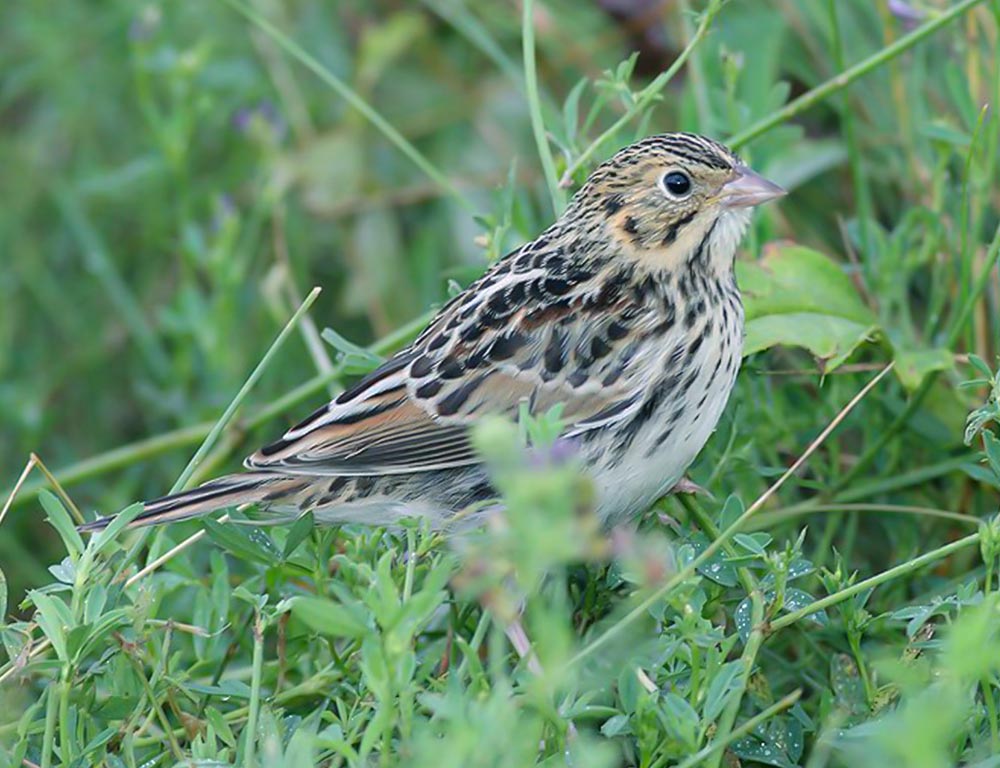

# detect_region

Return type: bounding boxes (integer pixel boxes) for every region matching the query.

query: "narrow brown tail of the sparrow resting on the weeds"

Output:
[79,472,304,531]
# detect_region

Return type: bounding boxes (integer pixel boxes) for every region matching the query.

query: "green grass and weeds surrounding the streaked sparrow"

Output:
[0,0,1000,768]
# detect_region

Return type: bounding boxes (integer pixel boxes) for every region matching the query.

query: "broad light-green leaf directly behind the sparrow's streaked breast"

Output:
[736,245,878,371]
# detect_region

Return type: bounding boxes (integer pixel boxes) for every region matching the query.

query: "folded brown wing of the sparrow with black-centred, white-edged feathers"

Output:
[244,251,660,475]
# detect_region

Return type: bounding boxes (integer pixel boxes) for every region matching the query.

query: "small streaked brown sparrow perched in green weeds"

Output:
[81,133,785,531]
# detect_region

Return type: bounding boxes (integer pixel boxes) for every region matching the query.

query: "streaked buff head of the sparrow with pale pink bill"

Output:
[567,133,785,269]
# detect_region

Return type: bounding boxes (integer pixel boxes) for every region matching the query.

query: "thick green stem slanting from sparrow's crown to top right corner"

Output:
[728,0,983,149]
